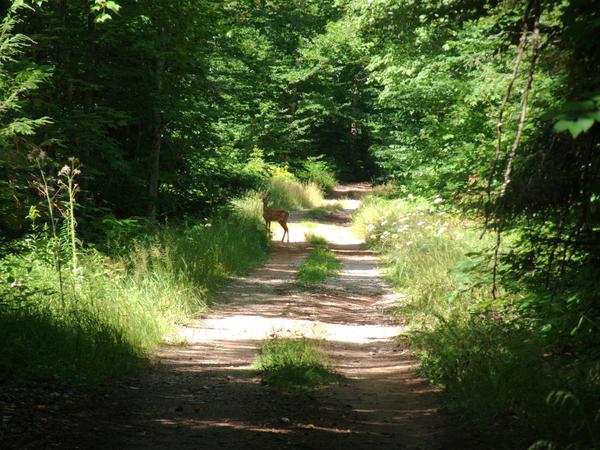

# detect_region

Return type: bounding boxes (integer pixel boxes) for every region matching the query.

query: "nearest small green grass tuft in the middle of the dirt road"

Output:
[254,337,343,389]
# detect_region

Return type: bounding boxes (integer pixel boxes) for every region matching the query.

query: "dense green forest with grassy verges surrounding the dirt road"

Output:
[0,0,600,449]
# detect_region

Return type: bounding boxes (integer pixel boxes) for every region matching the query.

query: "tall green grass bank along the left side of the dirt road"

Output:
[0,192,268,383]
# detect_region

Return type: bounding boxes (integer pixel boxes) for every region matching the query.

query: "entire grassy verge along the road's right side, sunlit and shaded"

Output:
[354,194,600,448]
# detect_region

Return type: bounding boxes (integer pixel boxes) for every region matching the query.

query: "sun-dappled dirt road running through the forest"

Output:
[0,184,478,449]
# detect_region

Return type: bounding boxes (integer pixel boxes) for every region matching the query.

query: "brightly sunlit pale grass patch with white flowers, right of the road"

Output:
[353,197,486,320]
